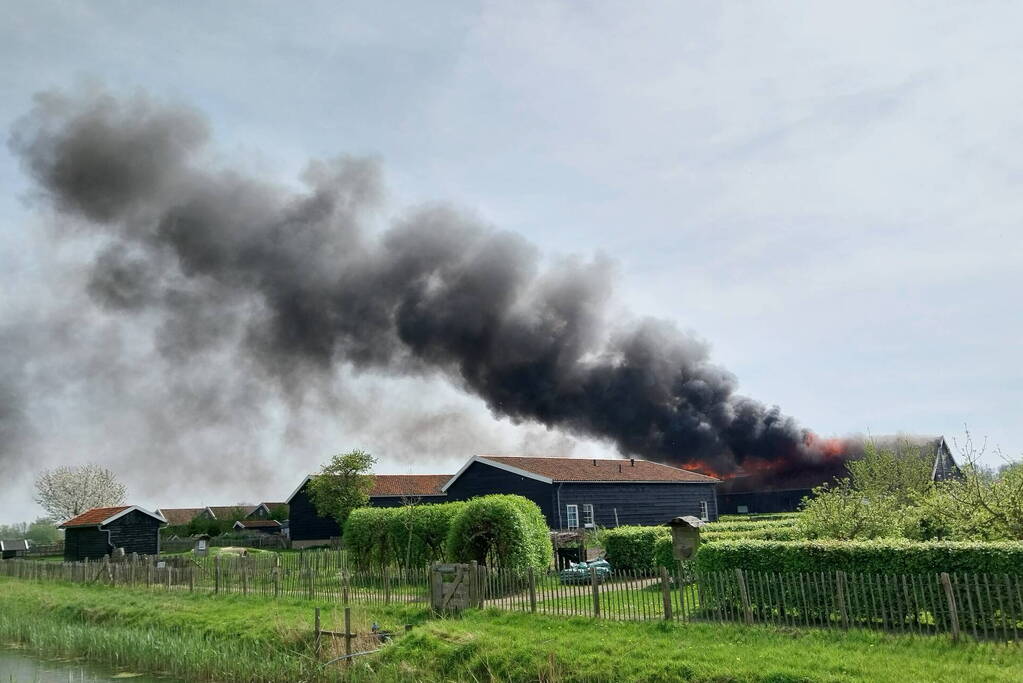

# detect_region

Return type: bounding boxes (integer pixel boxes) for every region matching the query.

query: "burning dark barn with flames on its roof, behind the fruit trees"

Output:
[717,436,962,514]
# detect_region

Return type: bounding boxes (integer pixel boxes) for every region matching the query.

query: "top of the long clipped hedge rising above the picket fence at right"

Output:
[696,539,1023,575]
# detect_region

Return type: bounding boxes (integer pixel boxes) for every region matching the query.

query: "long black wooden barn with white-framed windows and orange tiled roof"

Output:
[442,455,718,530]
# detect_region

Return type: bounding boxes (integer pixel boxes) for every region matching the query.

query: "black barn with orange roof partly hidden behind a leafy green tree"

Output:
[287,474,451,548]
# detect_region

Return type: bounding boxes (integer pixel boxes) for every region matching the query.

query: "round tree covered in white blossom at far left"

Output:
[36,463,127,520]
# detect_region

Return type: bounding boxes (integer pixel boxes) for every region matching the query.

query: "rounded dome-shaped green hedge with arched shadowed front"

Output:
[447,494,554,570]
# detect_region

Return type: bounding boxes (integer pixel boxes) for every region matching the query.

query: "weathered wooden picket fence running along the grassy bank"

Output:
[0,550,1023,642]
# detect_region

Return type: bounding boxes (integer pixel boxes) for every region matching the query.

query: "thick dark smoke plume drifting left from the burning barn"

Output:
[6,85,815,472]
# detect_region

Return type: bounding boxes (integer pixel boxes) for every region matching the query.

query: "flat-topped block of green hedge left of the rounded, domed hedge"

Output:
[343,502,465,566]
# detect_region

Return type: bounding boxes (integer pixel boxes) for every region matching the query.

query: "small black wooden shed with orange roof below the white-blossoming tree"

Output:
[60,505,167,562]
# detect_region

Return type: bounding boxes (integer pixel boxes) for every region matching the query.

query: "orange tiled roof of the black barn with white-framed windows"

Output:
[479,455,718,484]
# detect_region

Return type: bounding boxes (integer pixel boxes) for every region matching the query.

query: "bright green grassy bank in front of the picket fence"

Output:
[0,579,1023,683]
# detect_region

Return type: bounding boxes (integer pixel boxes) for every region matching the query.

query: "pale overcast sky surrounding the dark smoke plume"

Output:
[0,1,1023,522]
